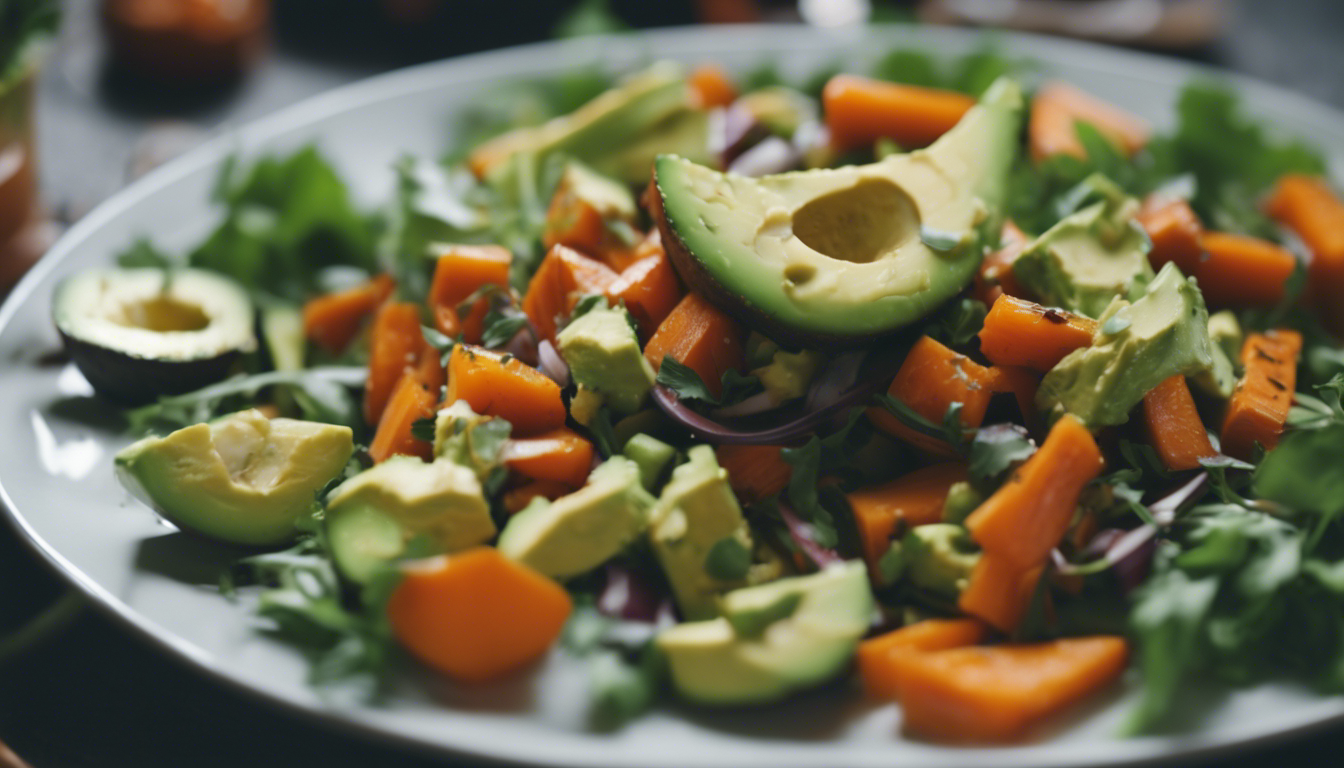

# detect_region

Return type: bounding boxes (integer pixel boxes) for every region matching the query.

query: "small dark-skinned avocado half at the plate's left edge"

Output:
[52,269,257,405]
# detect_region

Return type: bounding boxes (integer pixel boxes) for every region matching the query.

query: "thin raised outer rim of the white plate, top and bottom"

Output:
[0,24,1344,767]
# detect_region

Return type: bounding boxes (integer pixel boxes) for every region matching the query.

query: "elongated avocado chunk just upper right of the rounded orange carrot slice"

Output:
[497,456,653,578]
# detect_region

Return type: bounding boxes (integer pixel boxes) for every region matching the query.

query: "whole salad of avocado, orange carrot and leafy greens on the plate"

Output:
[54,43,1344,742]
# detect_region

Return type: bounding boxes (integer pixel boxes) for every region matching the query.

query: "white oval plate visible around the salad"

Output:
[0,27,1344,768]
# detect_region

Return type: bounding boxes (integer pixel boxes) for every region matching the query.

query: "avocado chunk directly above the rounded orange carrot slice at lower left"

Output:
[327,456,495,553]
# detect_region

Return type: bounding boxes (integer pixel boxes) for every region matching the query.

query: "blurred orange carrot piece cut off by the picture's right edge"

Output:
[1265,174,1344,335]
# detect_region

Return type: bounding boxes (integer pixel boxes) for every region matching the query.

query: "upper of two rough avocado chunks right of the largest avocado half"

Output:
[1012,174,1153,317]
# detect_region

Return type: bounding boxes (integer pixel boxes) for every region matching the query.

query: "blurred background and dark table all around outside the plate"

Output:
[0,0,1344,768]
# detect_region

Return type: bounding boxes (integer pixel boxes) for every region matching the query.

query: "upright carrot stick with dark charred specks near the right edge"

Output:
[1220,330,1302,461]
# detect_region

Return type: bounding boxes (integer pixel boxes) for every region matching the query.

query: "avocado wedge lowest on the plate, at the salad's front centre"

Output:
[655,562,874,705]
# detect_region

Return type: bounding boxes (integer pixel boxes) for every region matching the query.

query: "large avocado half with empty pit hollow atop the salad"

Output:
[650,78,1023,347]
